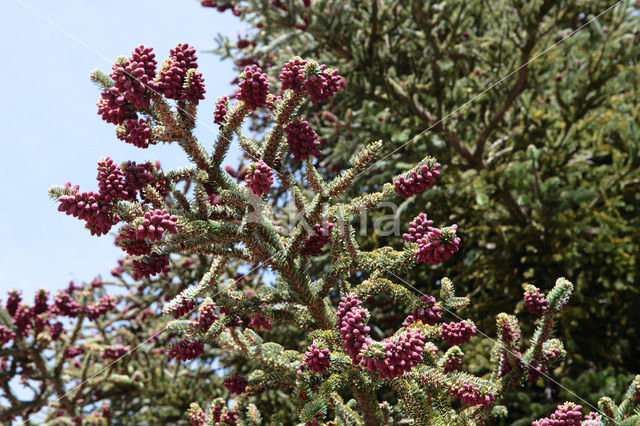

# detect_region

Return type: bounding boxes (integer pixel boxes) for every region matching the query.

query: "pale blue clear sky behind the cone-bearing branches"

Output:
[0,0,241,301]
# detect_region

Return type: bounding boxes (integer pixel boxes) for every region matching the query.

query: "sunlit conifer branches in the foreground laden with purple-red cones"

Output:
[25,39,640,425]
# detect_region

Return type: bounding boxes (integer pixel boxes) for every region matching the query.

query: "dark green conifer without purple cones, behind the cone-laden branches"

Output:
[209,0,640,382]
